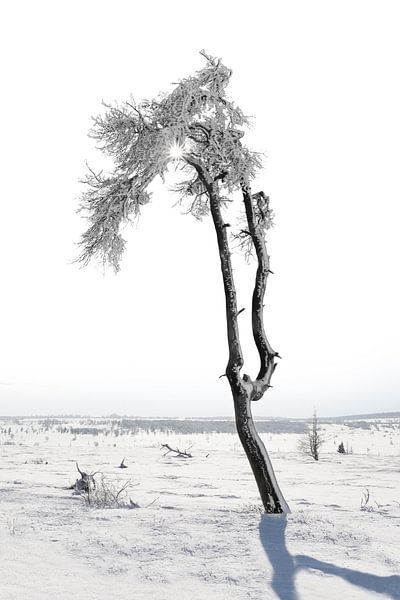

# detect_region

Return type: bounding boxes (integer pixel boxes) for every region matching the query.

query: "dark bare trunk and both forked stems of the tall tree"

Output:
[191,161,290,514]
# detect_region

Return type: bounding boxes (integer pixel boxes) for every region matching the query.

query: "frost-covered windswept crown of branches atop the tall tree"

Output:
[78,51,271,271]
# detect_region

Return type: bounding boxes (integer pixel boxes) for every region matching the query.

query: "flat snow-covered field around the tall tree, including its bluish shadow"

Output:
[0,418,400,600]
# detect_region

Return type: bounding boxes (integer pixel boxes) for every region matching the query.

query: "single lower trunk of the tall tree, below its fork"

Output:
[234,394,290,513]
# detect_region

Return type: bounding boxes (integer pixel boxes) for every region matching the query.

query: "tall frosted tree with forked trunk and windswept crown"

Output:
[79,51,289,513]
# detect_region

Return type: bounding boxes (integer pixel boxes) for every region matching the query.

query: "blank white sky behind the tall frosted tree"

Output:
[0,0,400,417]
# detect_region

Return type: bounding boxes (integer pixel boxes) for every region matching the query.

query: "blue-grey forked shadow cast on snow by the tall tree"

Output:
[259,515,400,600]
